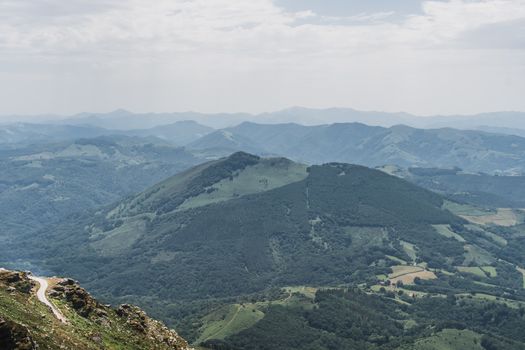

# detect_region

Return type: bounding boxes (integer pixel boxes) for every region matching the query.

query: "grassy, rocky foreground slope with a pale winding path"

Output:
[0,269,191,350]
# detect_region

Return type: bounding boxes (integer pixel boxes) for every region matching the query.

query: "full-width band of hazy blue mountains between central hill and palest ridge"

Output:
[0,116,525,175]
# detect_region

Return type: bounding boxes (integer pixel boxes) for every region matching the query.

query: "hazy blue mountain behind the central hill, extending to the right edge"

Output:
[188,123,525,174]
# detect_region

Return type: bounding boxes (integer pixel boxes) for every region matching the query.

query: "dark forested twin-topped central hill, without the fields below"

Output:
[24,153,463,300]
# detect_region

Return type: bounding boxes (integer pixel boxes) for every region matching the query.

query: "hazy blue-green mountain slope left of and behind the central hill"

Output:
[0,136,200,247]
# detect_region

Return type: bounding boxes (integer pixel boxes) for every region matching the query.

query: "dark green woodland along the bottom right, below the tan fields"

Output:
[204,289,525,350]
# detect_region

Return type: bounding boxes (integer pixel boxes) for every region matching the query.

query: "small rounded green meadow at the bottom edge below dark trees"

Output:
[402,329,483,350]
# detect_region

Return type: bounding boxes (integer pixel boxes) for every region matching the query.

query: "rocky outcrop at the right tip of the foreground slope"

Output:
[117,304,190,350]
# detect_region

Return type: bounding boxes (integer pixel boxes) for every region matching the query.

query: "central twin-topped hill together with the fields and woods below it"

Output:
[9,153,525,350]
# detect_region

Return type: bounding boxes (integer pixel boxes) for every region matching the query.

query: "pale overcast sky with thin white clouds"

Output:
[0,0,525,115]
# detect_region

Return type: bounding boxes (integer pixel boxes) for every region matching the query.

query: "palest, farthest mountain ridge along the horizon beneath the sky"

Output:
[4,107,525,134]
